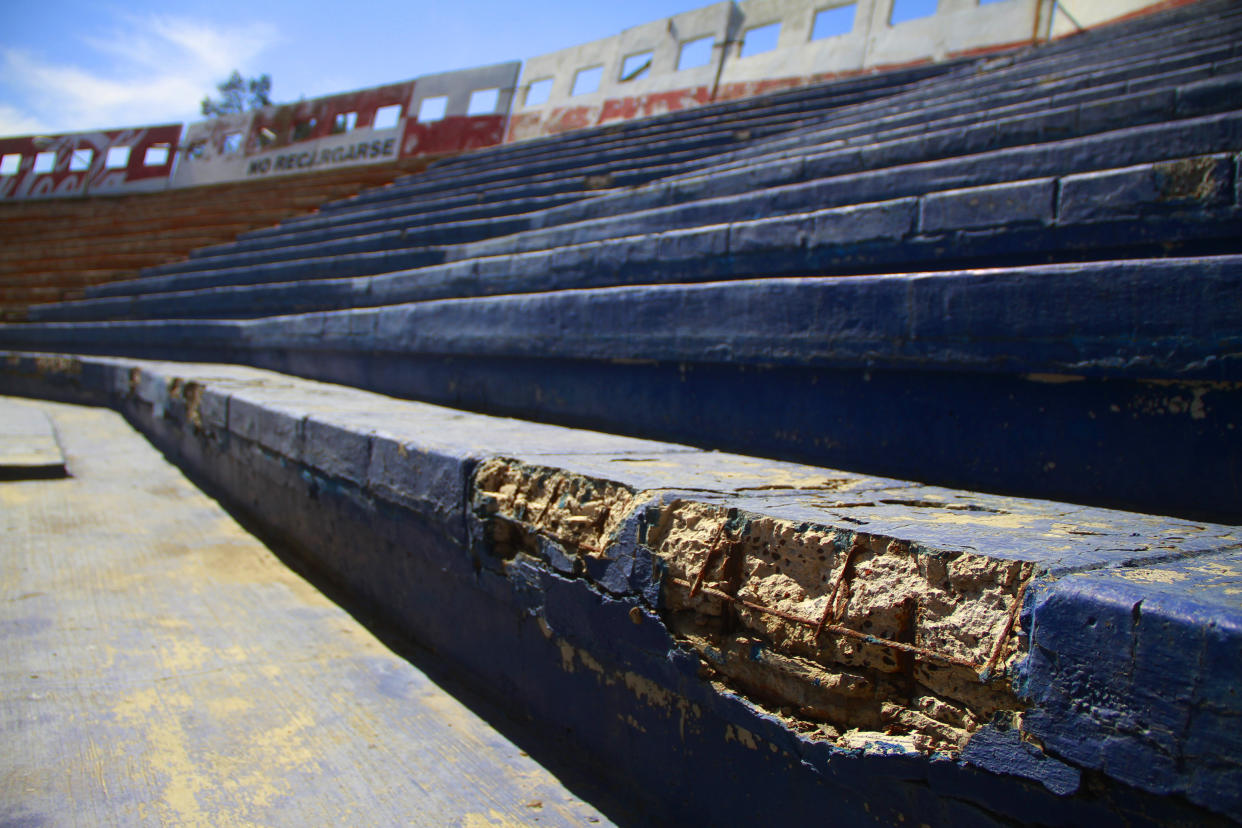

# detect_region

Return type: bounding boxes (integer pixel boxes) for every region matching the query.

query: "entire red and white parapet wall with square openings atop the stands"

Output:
[0,0,1189,201]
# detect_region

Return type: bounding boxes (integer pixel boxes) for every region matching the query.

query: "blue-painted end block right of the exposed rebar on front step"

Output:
[1021,547,1242,813]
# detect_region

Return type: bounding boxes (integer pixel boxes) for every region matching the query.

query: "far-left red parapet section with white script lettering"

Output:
[0,124,181,200]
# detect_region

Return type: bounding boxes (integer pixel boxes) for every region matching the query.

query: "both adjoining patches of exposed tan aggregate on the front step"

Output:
[474,458,1032,752]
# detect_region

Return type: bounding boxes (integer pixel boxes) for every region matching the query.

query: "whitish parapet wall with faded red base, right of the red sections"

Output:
[507,0,1177,140]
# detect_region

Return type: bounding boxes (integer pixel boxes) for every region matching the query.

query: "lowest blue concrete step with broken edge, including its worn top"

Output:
[0,354,1242,824]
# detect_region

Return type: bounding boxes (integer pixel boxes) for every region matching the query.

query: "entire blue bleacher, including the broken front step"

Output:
[0,0,1242,826]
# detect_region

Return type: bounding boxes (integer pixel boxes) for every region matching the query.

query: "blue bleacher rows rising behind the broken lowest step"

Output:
[12,2,1242,519]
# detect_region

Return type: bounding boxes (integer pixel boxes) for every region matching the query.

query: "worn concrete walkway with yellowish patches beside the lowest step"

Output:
[0,397,607,826]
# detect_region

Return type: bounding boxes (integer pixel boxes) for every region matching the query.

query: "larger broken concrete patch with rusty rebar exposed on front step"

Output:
[647,503,1032,752]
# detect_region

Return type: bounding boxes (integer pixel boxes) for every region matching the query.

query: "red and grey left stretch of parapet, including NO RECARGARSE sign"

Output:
[0,62,520,200]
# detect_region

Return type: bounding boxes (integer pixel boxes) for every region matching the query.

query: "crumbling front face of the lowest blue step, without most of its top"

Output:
[0,353,1242,824]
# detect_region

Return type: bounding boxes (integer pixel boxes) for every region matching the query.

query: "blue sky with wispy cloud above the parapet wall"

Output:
[0,0,709,135]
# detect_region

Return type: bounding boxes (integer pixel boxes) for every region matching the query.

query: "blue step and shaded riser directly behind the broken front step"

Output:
[0,256,1242,520]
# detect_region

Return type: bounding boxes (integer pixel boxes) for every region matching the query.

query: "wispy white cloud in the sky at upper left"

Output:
[0,16,277,135]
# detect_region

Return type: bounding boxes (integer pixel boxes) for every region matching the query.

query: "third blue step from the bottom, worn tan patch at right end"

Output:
[29,155,1242,322]
